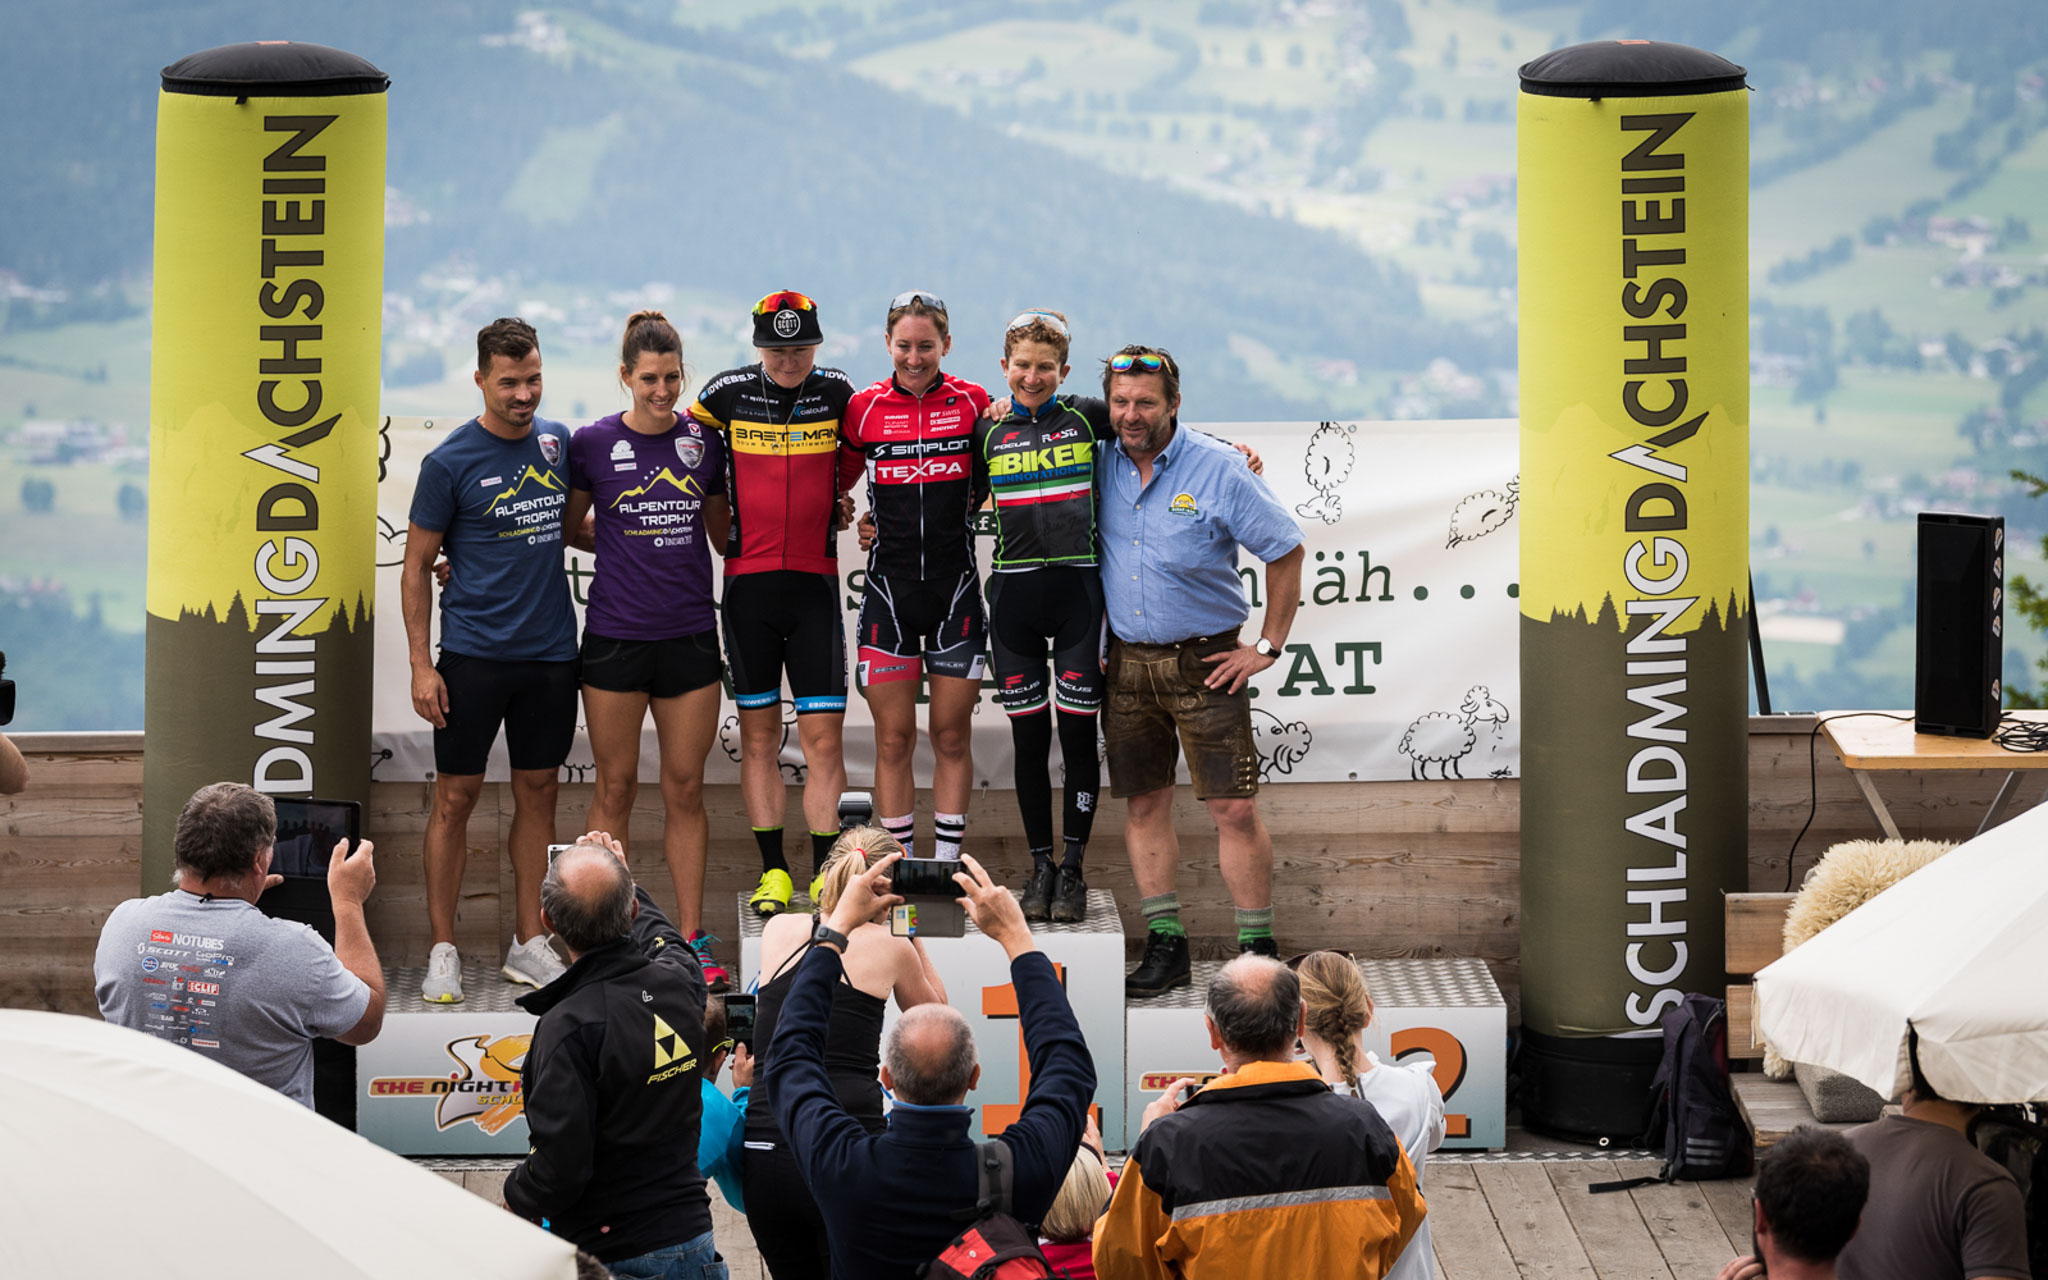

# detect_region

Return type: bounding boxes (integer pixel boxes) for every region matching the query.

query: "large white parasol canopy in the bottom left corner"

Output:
[0,1010,575,1280]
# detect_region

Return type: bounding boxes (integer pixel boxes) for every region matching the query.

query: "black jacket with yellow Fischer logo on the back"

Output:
[506,889,711,1262]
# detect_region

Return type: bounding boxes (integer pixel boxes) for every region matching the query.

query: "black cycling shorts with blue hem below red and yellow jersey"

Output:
[719,569,846,715]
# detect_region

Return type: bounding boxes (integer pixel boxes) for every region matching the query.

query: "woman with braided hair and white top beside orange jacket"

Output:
[1286,950,1444,1280]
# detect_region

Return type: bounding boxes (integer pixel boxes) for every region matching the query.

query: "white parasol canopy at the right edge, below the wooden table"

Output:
[1757,805,2048,1102]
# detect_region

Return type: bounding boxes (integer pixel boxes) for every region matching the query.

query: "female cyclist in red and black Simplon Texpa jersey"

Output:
[844,291,989,858]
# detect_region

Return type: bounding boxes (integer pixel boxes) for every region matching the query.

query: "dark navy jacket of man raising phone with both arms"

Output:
[764,946,1096,1280]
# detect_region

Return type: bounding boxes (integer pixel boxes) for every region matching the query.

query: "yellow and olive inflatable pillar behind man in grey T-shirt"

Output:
[141,41,391,893]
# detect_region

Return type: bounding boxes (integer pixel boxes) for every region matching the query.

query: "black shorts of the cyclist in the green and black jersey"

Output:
[989,565,1102,715]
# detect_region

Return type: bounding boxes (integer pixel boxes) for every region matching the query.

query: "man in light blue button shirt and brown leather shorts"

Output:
[1098,346,1303,995]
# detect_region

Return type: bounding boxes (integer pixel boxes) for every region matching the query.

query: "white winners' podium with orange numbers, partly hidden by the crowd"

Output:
[356,889,1507,1157]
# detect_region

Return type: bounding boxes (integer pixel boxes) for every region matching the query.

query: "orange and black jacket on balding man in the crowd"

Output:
[1096,1063,1425,1280]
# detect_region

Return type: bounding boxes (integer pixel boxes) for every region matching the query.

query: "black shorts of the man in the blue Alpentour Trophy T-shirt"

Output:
[434,649,578,778]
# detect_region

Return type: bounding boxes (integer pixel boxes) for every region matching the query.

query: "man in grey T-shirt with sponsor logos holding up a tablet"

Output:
[92,782,385,1106]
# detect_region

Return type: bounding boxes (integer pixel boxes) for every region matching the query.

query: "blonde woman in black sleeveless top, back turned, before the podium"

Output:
[741,827,946,1280]
